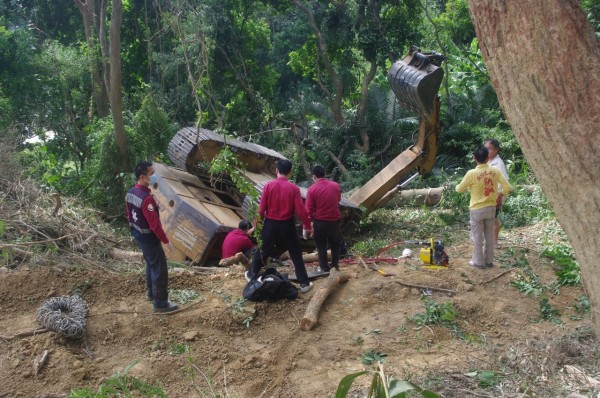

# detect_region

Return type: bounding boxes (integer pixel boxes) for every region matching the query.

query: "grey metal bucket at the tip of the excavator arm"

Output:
[387,47,445,117]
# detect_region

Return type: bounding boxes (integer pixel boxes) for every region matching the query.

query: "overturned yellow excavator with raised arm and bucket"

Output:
[151,47,444,265]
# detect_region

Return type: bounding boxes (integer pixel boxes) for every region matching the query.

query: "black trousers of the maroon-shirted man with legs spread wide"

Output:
[252,218,310,285]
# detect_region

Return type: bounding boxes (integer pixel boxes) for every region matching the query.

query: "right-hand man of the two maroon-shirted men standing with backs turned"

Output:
[306,164,343,272]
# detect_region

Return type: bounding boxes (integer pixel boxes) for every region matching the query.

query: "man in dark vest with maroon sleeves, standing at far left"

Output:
[125,162,178,312]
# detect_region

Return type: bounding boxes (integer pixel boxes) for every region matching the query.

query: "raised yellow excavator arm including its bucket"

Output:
[349,47,445,211]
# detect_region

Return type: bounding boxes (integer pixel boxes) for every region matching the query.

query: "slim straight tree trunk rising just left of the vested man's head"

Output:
[109,0,129,171]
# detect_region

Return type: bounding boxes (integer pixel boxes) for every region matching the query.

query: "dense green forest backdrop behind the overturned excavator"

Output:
[0,0,600,214]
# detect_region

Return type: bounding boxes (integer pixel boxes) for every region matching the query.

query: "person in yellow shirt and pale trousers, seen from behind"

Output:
[456,145,512,269]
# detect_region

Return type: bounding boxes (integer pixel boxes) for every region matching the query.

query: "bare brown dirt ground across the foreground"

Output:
[0,227,600,398]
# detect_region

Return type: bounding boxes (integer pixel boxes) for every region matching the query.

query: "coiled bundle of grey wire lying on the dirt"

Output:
[37,296,88,338]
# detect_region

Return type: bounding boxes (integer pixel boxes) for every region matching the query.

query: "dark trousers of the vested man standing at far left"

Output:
[133,231,169,308]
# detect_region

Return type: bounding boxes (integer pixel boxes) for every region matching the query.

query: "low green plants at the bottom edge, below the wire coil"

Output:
[67,362,167,398]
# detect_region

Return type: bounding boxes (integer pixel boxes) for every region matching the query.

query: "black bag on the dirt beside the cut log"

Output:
[243,268,298,301]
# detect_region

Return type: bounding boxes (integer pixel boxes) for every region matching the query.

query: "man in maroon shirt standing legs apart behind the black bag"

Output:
[246,159,313,293]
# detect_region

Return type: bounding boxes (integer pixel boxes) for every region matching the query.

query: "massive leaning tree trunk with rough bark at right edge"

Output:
[469,0,600,336]
